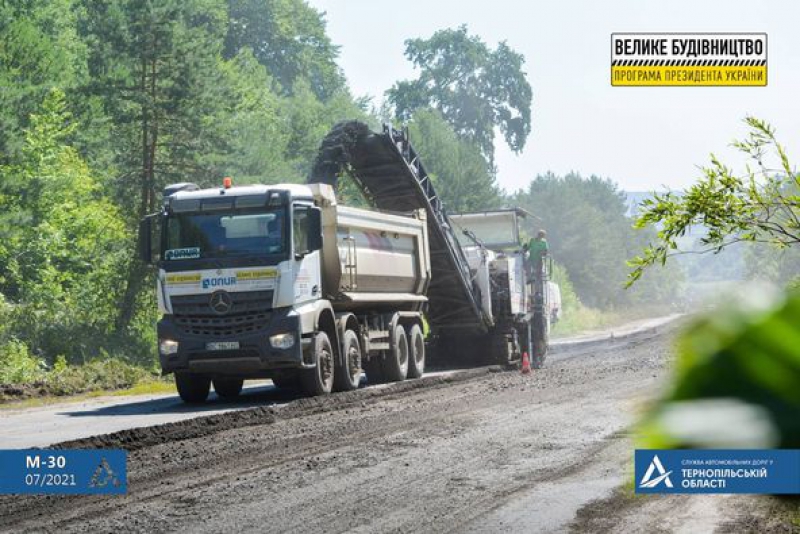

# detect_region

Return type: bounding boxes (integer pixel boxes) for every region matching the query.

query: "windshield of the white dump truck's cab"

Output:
[162,208,287,261]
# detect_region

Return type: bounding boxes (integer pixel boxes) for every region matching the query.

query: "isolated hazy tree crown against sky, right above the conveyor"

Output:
[387,26,532,163]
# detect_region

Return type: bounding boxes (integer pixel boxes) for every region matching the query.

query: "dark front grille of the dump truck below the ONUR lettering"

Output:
[172,291,273,337]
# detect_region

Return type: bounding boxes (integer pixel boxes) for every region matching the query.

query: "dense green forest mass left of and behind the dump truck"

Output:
[0,0,365,372]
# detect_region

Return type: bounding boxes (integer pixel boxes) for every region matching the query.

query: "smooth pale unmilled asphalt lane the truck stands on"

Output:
[0,315,679,449]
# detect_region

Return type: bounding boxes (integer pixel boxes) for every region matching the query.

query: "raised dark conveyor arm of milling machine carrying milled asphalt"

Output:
[309,121,492,332]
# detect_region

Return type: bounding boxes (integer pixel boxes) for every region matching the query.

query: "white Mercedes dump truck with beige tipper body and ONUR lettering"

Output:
[142,180,430,402]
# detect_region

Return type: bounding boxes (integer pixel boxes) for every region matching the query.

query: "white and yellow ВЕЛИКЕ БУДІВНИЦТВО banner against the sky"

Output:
[611,33,767,87]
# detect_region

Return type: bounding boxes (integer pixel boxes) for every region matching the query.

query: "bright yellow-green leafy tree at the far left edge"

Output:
[0,90,129,359]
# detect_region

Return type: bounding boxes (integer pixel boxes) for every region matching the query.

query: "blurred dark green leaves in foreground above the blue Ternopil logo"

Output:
[641,285,800,449]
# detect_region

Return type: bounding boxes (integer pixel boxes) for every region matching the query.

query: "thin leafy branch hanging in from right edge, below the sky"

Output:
[628,117,800,284]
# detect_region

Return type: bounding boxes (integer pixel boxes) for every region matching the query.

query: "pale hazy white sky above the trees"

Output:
[309,0,800,191]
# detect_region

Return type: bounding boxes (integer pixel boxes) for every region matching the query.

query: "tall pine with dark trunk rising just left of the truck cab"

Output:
[79,0,229,328]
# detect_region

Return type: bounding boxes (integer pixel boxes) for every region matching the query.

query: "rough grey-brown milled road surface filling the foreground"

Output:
[0,326,692,532]
